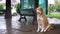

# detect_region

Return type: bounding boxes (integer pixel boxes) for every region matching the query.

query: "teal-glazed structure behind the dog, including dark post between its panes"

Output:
[20,0,47,19]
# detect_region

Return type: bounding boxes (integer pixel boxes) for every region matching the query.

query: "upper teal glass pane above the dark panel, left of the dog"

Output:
[21,0,34,9]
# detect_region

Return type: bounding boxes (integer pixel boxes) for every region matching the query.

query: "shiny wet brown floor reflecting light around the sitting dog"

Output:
[0,16,60,34]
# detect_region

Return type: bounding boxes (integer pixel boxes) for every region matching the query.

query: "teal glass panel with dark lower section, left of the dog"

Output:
[20,0,34,16]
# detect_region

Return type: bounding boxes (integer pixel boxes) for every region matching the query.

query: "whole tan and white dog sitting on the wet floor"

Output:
[36,7,52,32]
